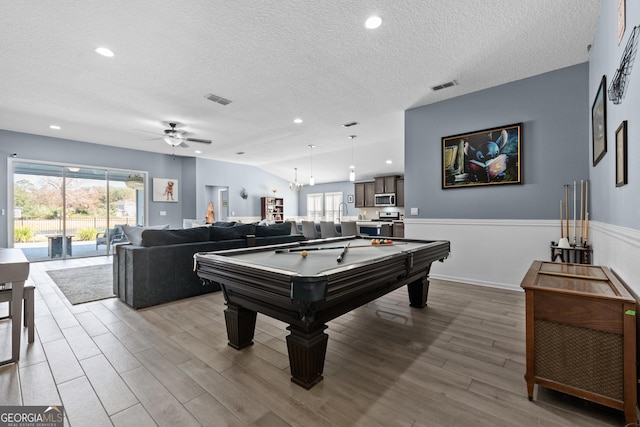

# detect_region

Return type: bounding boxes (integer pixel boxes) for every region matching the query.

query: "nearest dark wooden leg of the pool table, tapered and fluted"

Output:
[287,325,329,390]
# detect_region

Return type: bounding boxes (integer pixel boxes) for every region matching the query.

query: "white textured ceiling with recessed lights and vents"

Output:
[0,0,600,183]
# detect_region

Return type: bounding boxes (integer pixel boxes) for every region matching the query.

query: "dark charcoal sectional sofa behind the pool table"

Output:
[113,223,304,309]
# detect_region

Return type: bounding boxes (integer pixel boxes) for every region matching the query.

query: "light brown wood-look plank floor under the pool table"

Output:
[0,257,624,427]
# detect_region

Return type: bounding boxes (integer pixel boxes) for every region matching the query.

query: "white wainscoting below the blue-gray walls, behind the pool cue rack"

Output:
[404,218,640,295]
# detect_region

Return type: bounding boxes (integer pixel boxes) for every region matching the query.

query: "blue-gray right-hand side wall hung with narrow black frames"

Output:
[588,1,640,230]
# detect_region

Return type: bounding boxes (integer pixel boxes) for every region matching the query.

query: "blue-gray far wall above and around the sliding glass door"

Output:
[0,129,298,247]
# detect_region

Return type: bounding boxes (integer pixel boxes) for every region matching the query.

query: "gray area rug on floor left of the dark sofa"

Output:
[47,264,115,305]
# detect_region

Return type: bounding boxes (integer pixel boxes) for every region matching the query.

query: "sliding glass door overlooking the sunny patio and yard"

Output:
[12,162,145,261]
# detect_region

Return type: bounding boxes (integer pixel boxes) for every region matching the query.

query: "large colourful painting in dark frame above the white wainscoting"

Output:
[442,123,522,189]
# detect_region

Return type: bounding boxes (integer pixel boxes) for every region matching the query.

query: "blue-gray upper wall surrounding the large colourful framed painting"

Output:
[405,63,589,219]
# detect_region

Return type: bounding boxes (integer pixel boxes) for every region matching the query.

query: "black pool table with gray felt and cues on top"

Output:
[194,236,450,389]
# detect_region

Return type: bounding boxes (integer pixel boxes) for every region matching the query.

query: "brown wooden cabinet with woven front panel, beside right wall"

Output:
[520,261,637,425]
